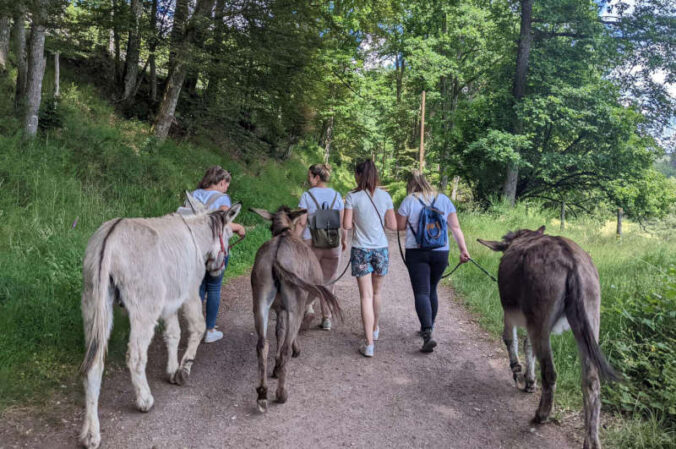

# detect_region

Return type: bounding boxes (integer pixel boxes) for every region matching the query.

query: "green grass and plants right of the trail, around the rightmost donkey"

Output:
[451,204,676,448]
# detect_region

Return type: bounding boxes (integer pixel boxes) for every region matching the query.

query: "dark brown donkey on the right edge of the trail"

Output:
[478,226,618,448]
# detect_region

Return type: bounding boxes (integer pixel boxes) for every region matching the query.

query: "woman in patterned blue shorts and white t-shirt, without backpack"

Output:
[343,159,397,357]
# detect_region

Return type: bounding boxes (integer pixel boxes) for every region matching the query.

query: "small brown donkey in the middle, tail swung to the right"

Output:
[251,206,341,412]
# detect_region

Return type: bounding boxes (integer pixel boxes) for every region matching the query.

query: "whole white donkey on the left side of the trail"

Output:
[80,194,241,448]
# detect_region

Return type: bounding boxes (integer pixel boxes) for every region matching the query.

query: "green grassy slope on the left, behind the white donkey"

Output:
[0,72,349,410]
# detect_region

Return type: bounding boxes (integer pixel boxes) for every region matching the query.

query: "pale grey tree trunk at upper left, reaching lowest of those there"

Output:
[24,21,47,137]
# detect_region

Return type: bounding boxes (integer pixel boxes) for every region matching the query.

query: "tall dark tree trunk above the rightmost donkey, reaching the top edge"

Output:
[502,0,533,205]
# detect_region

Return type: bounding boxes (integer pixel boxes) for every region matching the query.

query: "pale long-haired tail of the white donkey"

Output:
[80,218,122,374]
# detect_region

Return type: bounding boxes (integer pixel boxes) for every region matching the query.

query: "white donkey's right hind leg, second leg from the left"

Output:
[127,316,157,412]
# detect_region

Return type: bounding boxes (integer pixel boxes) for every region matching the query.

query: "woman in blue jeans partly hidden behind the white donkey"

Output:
[192,165,246,343]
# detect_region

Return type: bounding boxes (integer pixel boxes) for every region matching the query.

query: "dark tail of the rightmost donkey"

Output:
[565,268,621,382]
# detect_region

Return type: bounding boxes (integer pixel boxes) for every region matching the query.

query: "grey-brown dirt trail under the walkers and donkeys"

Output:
[0,236,581,449]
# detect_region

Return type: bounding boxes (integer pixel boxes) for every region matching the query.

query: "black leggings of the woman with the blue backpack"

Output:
[406,248,448,330]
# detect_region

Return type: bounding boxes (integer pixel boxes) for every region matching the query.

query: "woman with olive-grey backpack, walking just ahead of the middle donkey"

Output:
[296,164,347,331]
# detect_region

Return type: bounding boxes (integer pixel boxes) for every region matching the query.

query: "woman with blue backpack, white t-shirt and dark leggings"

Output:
[397,170,470,353]
